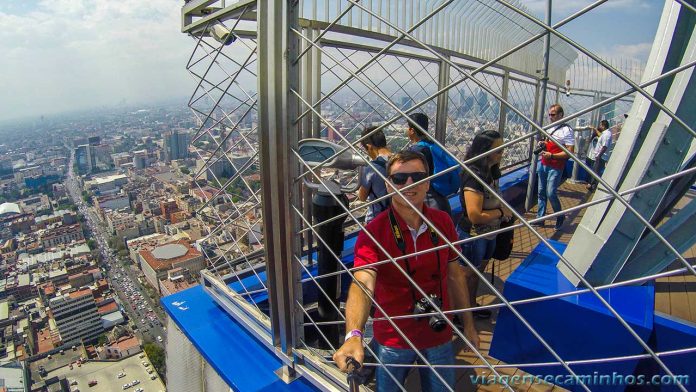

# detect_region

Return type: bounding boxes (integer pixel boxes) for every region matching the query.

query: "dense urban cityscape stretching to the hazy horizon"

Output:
[0,86,540,391]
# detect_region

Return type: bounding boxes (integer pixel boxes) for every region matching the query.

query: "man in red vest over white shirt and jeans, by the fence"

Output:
[533,104,575,230]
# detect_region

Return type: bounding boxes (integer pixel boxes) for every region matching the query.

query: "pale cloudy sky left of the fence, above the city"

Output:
[0,0,194,120]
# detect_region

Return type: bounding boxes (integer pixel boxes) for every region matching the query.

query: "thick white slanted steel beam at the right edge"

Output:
[559,3,696,285]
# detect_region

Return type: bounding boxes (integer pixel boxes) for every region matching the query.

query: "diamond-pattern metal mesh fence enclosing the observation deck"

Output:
[181,1,696,390]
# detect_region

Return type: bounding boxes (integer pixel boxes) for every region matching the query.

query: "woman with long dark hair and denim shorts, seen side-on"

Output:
[457,130,512,318]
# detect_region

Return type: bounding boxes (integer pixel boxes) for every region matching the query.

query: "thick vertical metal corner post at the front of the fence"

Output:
[257,1,301,381]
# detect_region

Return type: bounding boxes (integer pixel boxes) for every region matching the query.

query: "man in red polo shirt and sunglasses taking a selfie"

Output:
[334,151,478,391]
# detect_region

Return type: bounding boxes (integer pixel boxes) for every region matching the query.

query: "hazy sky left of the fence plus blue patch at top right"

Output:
[0,0,663,121]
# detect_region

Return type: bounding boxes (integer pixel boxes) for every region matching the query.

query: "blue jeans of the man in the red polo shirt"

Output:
[375,342,455,392]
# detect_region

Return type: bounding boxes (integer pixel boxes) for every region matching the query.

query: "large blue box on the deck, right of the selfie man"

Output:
[490,241,655,391]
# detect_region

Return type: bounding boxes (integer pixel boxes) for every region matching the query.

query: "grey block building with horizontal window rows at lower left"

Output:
[49,289,104,343]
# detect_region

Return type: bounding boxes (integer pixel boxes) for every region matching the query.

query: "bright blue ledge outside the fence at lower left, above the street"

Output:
[161,286,316,391]
